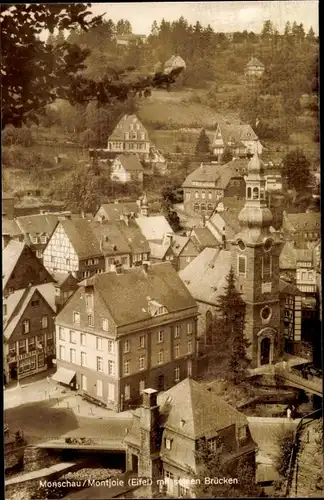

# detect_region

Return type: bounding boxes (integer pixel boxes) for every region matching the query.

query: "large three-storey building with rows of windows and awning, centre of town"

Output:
[55,263,197,411]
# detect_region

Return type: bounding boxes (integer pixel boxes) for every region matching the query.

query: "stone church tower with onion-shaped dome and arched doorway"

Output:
[230,154,283,368]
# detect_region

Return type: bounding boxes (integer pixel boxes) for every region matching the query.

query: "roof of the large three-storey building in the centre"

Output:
[57,262,196,327]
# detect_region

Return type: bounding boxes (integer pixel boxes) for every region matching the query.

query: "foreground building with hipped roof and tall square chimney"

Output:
[125,378,256,498]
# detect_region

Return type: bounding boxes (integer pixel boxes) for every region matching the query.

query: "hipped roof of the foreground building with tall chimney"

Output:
[158,378,248,440]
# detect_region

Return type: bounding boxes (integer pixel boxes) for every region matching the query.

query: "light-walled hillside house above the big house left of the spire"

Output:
[211,123,263,160]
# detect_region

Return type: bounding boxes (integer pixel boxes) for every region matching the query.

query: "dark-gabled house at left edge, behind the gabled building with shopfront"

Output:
[2,240,54,297]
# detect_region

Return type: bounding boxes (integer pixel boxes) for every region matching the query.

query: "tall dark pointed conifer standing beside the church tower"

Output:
[207,268,250,384]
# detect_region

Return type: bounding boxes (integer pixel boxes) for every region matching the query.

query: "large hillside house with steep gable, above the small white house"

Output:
[107,115,150,159]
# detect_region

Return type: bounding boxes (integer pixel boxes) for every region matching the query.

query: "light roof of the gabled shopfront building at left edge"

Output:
[3,283,56,340]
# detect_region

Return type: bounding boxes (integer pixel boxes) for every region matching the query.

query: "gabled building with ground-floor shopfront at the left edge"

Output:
[3,283,56,383]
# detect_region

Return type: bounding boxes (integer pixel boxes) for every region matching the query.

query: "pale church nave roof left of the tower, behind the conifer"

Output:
[179,248,232,304]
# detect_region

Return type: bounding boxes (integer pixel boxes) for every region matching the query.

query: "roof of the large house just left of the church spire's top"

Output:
[182,161,241,189]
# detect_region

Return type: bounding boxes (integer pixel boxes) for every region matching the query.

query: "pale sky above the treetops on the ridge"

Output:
[87,0,319,35]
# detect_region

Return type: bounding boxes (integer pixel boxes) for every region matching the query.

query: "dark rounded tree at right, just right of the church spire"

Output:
[282,148,310,192]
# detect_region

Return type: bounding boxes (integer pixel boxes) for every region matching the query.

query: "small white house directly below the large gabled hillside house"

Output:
[110,154,144,184]
